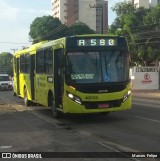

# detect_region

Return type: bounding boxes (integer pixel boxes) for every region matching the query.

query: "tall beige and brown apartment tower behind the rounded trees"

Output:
[52,0,108,33]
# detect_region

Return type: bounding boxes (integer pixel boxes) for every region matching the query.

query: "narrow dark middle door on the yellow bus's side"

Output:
[30,54,35,100]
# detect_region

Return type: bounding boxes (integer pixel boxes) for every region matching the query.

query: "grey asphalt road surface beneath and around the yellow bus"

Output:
[0,91,160,161]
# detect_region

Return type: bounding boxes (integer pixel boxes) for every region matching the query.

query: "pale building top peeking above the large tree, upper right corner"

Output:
[129,0,160,8]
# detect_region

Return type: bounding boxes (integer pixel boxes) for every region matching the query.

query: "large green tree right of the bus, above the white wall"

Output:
[110,1,160,65]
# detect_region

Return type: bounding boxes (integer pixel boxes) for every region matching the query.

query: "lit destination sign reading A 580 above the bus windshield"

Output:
[77,38,117,47]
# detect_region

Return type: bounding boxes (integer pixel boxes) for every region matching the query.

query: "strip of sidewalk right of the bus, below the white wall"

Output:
[132,90,160,101]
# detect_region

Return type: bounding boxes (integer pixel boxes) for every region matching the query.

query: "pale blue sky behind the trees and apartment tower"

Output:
[0,0,124,53]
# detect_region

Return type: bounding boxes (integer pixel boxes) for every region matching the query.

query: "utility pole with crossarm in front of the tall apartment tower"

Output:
[89,0,103,34]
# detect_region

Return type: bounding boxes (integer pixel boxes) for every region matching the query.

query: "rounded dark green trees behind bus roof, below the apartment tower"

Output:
[29,16,95,43]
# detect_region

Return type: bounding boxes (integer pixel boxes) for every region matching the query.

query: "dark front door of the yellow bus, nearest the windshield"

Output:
[54,48,64,107]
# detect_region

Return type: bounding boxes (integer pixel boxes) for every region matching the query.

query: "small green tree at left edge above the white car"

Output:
[0,52,13,75]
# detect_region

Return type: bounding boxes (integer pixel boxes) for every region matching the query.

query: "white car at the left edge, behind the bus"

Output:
[0,74,13,90]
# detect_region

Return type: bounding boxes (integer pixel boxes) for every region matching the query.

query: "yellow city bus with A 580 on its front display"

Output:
[13,34,132,118]
